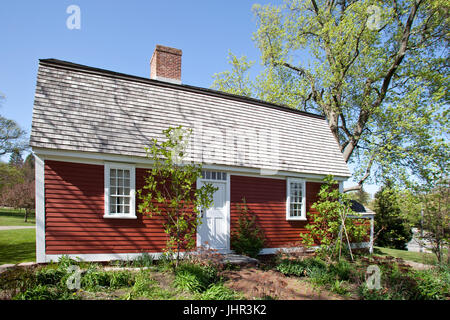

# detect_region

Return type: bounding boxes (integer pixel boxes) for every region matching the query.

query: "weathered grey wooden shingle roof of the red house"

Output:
[30,59,350,177]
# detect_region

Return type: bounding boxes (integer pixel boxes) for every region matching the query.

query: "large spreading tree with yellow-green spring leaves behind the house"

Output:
[213,0,450,190]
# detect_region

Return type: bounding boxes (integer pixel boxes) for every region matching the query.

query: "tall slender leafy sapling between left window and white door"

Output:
[138,126,216,268]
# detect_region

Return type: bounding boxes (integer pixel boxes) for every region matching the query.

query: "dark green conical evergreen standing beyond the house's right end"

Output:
[375,181,412,250]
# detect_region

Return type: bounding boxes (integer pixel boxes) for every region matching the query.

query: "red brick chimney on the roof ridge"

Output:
[150,44,182,84]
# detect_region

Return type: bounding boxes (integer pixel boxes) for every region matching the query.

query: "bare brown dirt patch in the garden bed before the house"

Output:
[224,268,344,300]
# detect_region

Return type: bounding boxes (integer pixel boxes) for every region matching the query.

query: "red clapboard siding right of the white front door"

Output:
[230,175,321,248]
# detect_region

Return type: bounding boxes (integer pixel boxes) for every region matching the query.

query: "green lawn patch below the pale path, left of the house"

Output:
[0,229,36,265]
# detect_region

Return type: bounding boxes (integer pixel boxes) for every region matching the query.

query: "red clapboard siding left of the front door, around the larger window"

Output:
[45,160,166,254]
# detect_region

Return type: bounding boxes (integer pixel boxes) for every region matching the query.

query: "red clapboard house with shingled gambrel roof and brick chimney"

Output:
[30,46,372,262]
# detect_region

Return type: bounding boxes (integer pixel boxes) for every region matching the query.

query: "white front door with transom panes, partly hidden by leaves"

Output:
[197,181,229,250]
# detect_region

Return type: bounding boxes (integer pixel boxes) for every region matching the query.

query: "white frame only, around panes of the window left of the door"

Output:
[103,163,137,219]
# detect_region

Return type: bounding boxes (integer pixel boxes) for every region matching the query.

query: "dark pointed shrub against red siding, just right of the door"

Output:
[231,199,264,258]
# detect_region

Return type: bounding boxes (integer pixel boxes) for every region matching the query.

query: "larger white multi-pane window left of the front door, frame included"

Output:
[105,164,136,218]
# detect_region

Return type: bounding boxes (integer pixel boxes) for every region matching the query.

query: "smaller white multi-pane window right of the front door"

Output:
[286,178,306,220]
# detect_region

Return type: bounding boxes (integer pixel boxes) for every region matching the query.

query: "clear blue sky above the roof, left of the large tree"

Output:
[0,0,376,192]
